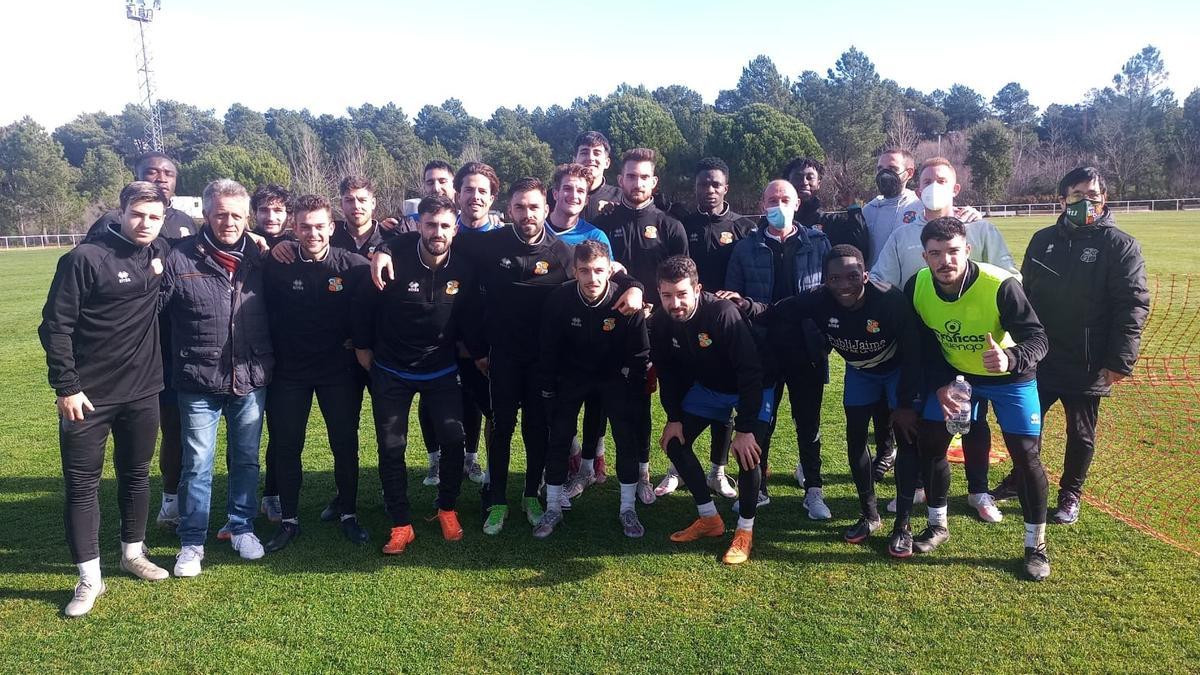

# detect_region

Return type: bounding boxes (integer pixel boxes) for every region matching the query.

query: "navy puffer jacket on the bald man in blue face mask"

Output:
[725,219,830,374]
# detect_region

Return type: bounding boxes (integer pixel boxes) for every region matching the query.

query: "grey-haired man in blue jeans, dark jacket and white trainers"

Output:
[160,179,275,577]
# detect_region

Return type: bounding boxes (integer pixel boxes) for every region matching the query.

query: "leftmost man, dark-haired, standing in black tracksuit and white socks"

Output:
[37,181,169,617]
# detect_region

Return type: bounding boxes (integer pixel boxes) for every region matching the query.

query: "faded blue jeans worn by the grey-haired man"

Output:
[176,388,266,546]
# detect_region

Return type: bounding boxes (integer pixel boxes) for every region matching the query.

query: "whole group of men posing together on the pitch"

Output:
[40,132,1148,616]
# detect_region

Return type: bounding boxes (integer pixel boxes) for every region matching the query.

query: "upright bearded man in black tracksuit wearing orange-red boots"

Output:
[354,195,479,555]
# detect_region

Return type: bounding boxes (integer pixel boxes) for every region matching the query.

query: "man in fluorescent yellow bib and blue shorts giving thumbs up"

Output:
[898,216,1050,581]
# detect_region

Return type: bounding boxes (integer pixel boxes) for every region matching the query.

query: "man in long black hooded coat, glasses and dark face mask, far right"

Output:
[996,167,1150,525]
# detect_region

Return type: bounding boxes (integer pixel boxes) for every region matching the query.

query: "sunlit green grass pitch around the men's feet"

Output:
[0,208,1200,673]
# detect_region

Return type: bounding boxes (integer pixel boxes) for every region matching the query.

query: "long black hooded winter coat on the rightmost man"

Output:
[1021,211,1150,396]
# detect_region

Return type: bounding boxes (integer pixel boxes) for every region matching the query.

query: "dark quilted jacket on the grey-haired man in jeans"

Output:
[158,229,275,396]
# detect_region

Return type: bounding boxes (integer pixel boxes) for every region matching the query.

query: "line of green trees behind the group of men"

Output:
[0,46,1200,234]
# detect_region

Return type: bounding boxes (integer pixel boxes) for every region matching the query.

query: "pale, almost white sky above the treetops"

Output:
[0,0,1200,129]
